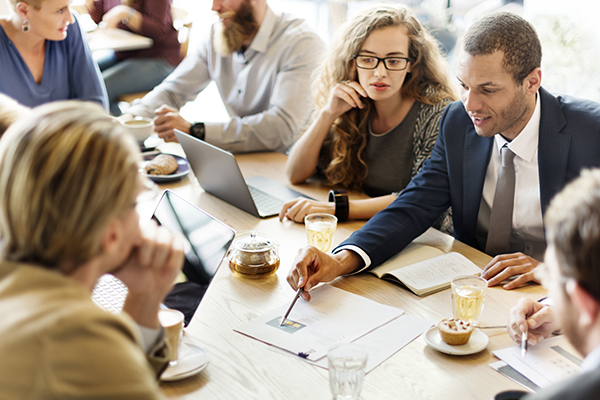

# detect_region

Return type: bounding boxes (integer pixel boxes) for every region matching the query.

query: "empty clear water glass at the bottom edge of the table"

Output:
[327,343,367,400]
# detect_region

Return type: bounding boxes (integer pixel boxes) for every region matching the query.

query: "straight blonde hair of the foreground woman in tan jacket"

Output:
[0,101,140,268]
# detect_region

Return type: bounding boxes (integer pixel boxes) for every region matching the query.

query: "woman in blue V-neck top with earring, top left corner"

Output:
[0,0,108,108]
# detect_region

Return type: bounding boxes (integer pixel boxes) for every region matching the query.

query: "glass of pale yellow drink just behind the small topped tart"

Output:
[450,275,487,326]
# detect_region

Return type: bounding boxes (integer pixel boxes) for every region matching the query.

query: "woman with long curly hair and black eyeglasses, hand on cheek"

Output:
[279,4,457,230]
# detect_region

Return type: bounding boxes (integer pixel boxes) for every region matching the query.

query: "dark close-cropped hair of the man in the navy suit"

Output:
[463,12,542,86]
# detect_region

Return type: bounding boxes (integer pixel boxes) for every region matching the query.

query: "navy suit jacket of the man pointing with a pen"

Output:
[338,88,600,266]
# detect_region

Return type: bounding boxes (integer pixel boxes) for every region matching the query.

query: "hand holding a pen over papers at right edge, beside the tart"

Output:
[508,298,559,346]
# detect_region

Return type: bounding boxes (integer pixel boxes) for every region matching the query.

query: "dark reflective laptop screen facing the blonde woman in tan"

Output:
[152,190,235,285]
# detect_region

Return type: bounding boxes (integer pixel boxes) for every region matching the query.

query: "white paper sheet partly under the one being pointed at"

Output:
[314,314,434,373]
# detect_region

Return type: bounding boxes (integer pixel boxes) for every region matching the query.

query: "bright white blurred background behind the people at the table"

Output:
[0,0,600,121]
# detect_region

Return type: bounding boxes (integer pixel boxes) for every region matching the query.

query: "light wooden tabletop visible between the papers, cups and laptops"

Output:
[149,145,545,400]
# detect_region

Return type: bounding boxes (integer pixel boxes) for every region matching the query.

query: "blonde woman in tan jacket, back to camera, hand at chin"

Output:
[0,102,183,399]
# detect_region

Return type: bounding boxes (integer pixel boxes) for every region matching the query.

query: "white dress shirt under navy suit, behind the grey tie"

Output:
[477,95,546,260]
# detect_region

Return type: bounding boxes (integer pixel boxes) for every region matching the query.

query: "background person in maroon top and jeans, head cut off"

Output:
[85,0,182,116]
